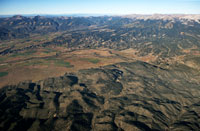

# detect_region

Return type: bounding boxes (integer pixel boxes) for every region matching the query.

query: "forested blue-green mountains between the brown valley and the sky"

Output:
[0,15,200,57]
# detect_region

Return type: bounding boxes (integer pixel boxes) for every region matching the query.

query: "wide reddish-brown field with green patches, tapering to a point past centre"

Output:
[0,49,124,87]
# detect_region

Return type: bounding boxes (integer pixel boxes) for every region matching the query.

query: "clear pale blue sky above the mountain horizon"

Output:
[0,0,200,15]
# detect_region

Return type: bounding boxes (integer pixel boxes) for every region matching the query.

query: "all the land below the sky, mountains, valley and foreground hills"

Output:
[0,14,200,131]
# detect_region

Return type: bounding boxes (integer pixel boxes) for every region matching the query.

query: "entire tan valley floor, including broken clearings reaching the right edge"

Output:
[0,43,200,87]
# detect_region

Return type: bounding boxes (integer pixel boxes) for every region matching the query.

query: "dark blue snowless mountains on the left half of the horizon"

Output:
[0,15,97,40]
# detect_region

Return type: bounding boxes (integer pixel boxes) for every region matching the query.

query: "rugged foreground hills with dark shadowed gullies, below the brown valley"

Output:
[0,61,200,131]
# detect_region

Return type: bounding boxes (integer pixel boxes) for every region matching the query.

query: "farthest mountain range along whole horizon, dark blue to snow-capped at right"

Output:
[0,14,200,40]
